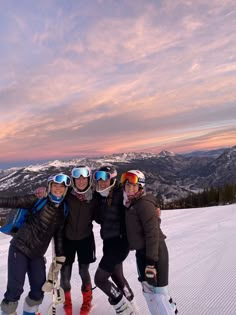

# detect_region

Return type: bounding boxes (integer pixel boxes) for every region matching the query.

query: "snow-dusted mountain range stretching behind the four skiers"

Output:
[0,146,236,204]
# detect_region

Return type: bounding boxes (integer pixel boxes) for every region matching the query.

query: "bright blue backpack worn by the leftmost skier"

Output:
[0,197,68,236]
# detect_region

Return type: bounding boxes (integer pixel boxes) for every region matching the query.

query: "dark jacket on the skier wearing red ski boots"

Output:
[65,190,95,240]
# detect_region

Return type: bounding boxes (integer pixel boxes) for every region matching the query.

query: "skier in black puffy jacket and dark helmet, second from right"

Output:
[94,166,137,315]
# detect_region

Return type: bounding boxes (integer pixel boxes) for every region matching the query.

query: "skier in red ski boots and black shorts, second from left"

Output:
[35,165,96,315]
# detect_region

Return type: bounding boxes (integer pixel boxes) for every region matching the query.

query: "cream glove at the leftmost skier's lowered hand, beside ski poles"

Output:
[42,256,66,292]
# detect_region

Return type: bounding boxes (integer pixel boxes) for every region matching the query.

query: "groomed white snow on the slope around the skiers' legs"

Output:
[0,204,236,315]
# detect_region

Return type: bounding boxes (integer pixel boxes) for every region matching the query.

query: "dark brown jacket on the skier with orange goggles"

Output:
[125,194,166,264]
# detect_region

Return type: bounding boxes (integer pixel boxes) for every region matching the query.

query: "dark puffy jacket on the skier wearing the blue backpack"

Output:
[0,195,65,258]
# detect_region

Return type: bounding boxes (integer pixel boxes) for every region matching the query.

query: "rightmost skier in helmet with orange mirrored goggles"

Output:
[121,170,177,315]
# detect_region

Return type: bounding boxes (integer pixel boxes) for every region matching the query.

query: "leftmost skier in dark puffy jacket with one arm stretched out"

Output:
[0,173,71,315]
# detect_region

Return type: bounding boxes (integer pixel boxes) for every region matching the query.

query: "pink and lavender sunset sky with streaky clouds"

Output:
[0,0,236,168]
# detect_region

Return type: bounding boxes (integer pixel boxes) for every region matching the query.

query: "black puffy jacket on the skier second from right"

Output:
[94,186,126,240]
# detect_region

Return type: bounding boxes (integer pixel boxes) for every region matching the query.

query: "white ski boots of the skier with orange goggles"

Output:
[142,281,178,315]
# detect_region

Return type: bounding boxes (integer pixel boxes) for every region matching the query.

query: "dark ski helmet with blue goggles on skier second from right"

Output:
[93,165,117,193]
